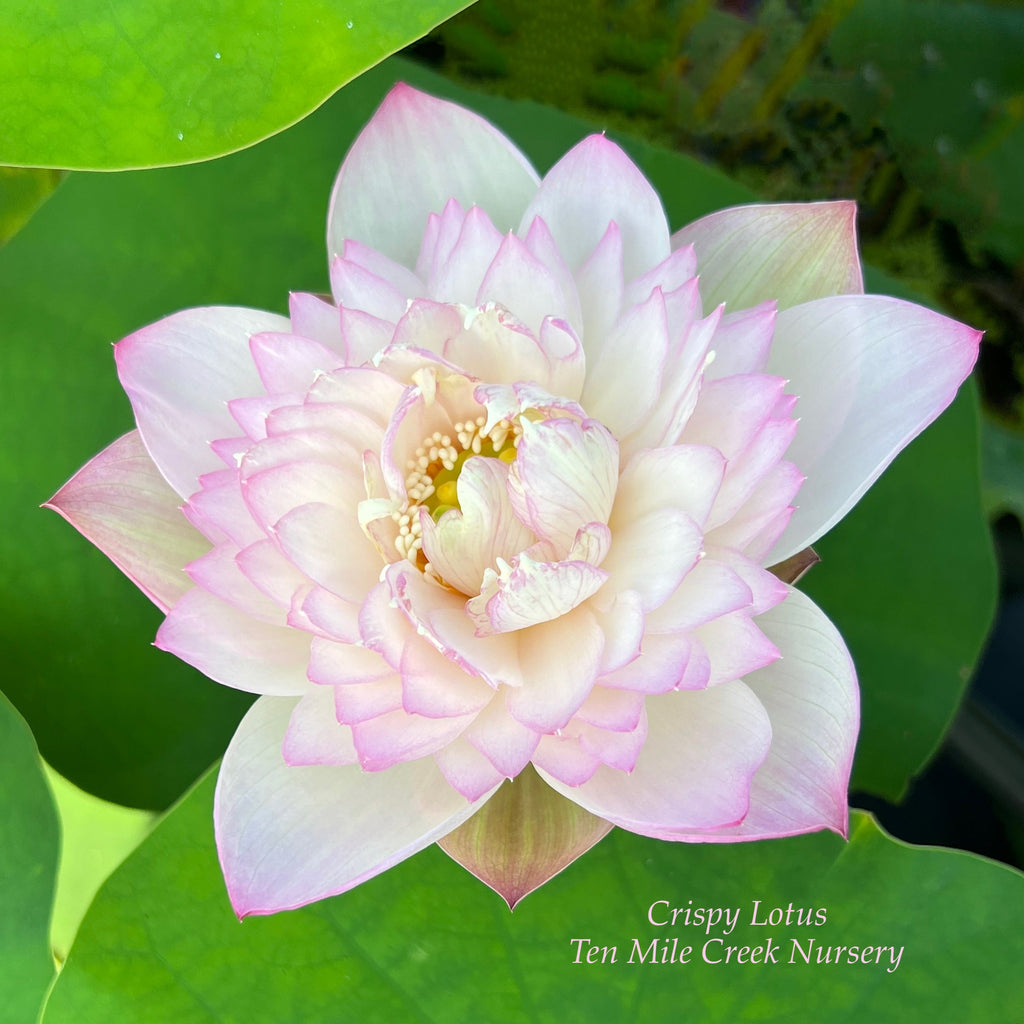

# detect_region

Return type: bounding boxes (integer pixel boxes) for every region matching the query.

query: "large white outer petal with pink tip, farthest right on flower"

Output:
[768,295,981,564]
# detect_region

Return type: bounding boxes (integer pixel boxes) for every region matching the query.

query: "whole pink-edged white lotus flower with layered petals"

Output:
[44,85,979,915]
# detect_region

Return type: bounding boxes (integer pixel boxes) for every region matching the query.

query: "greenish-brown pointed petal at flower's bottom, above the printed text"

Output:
[439,768,611,909]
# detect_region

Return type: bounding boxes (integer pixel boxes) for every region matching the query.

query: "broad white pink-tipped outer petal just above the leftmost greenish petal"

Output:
[114,306,291,498]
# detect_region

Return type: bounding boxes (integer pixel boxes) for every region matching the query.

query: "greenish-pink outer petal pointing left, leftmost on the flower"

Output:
[45,430,210,611]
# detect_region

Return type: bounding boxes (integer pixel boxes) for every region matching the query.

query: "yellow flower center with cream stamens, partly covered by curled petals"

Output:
[392,416,522,574]
